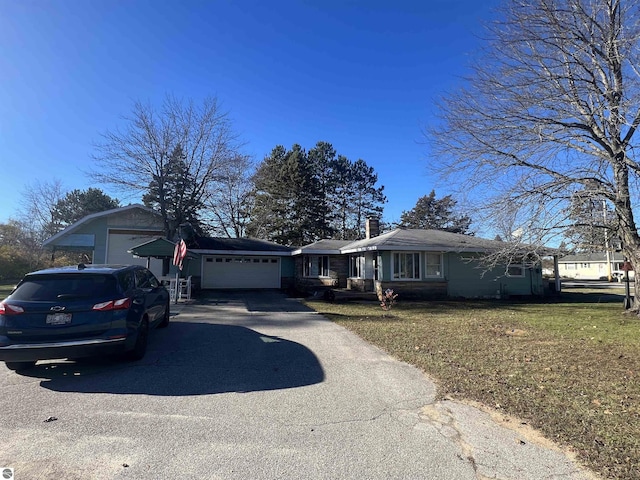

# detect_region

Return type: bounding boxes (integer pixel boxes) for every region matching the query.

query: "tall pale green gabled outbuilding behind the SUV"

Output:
[43,204,164,276]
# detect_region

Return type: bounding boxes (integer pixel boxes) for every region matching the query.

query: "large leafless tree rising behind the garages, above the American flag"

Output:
[90,96,239,238]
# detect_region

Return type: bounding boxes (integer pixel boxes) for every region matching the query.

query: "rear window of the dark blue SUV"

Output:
[11,274,117,302]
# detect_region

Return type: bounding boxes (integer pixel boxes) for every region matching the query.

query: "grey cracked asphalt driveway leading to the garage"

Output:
[0,292,591,480]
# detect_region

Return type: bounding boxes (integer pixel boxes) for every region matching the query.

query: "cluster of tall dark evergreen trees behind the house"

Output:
[247,142,386,245]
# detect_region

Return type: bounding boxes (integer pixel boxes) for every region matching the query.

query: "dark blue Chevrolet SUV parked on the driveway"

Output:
[0,264,170,370]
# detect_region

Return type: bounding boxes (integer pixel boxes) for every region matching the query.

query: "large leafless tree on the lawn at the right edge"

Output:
[427,0,640,308]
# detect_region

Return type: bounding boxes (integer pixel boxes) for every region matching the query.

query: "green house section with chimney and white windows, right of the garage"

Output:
[293,223,544,298]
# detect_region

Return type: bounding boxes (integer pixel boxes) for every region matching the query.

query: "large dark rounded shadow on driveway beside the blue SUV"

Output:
[16,321,324,396]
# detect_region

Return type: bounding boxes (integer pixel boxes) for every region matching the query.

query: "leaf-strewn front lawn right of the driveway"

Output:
[308,290,640,479]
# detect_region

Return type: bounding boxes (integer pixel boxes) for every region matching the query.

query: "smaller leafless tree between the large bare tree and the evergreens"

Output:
[205,155,254,238]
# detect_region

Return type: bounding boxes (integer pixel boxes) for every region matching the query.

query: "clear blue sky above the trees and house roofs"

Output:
[0,0,497,227]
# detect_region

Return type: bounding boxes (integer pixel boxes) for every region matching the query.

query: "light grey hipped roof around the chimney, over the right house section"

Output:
[341,228,504,253]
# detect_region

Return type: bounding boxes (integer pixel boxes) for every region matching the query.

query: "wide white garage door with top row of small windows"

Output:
[202,255,280,288]
